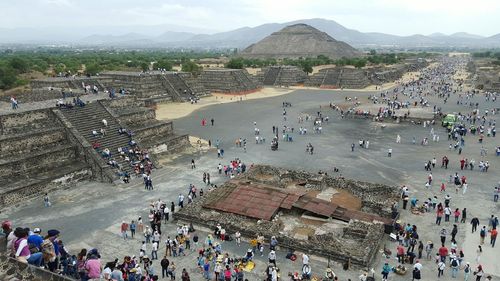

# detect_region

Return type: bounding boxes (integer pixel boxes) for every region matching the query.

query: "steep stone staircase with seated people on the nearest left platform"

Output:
[61,102,133,175]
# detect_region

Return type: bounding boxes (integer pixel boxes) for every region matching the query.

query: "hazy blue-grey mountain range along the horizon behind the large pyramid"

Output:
[0,19,500,49]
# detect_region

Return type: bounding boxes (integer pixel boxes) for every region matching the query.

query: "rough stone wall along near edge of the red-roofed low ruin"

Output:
[173,196,384,267]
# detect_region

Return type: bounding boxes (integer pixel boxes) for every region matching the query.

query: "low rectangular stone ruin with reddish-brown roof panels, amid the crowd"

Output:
[174,165,399,267]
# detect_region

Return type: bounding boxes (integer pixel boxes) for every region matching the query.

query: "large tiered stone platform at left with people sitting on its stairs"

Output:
[0,97,189,207]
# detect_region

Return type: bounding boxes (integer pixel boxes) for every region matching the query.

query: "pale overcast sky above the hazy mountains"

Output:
[0,0,500,36]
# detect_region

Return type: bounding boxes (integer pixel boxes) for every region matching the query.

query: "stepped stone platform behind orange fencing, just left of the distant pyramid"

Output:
[198,68,259,94]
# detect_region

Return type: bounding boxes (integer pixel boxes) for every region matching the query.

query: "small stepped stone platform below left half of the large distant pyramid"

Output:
[256,65,307,87]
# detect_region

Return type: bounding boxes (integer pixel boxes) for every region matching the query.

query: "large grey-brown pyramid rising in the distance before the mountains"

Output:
[240,24,362,59]
